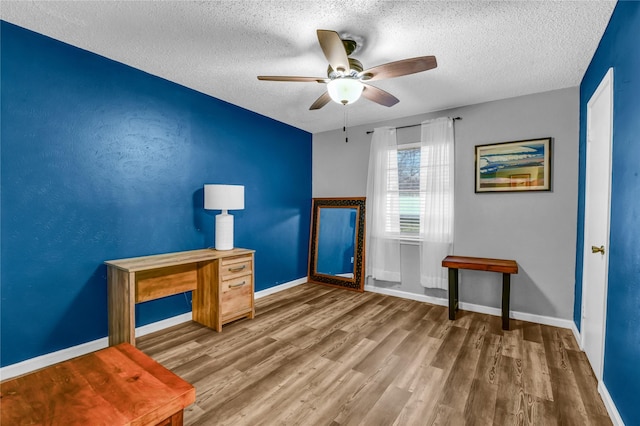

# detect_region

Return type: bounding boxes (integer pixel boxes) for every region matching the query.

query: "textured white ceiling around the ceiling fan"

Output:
[0,0,615,133]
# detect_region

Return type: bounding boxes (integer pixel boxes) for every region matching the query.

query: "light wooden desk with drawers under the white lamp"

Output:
[105,248,255,346]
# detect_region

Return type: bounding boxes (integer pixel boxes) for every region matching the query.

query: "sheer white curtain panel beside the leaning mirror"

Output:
[366,127,401,282]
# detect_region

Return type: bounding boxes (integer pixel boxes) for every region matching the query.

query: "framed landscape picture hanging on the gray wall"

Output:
[475,137,551,193]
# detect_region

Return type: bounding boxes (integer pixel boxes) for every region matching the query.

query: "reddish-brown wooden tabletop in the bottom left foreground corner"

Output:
[0,343,196,426]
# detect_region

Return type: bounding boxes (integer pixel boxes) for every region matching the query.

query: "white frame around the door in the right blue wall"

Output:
[580,68,614,382]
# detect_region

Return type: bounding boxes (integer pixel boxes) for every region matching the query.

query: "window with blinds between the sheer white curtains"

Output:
[386,143,424,240]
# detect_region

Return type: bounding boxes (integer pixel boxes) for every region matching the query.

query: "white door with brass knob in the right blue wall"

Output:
[581,68,613,381]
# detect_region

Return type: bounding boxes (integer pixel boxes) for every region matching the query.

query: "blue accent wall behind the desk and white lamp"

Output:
[0,21,312,366]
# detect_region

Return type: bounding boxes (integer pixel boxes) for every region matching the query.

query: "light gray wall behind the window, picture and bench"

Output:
[312,87,579,319]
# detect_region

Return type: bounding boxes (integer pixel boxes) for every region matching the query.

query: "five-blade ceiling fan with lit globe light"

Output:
[258,30,438,110]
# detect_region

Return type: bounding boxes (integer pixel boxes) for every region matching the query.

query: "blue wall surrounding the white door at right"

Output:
[574,1,640,425]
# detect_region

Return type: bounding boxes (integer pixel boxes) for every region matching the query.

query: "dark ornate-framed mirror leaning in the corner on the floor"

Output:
[308,197,366,291]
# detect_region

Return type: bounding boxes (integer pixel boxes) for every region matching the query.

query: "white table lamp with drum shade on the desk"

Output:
[204,184,244,250]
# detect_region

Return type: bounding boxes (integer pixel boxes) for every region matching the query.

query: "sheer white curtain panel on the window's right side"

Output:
[420,117,454,289]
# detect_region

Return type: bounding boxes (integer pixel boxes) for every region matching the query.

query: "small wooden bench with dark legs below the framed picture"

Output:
[442,256,518,330]
